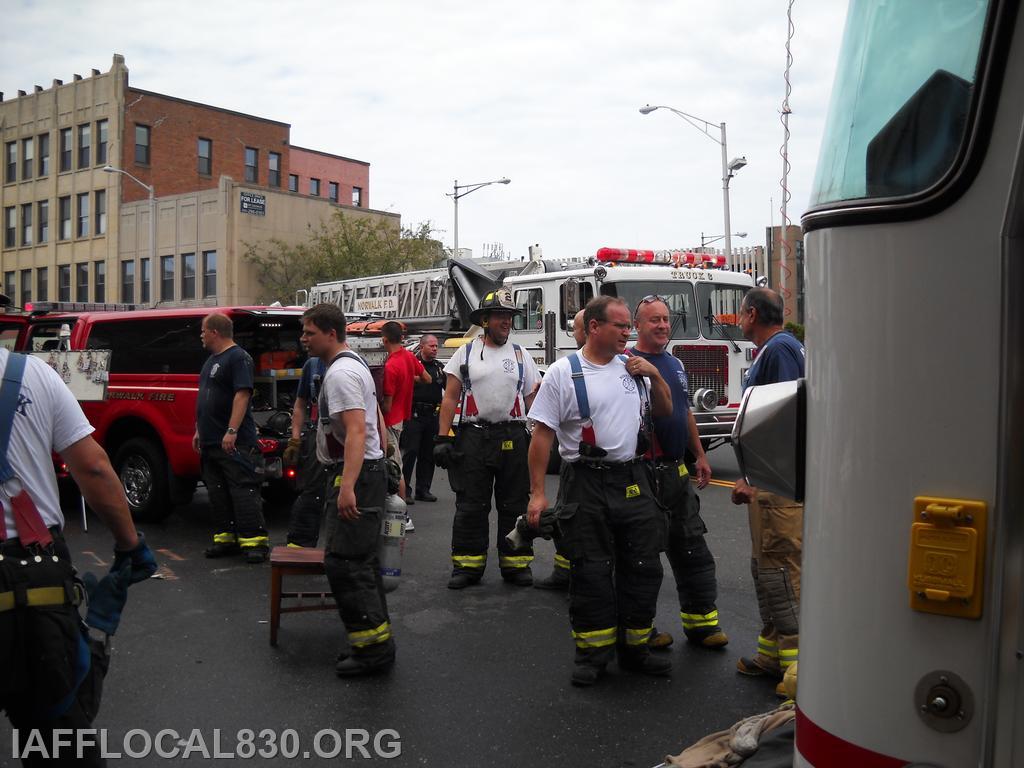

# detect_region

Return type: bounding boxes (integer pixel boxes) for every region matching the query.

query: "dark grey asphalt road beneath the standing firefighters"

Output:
[0,447,777,768]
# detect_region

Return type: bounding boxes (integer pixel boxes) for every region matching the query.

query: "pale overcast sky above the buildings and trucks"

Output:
[0,0,846,258]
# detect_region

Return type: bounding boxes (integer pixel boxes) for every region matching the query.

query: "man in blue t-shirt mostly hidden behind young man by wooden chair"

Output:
[285,357,327,547]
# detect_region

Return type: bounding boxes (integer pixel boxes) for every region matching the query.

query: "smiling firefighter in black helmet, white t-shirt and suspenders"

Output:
[434,289,540,590]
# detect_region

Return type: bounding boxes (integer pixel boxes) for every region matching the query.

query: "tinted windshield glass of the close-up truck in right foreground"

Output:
[811,0,989,206]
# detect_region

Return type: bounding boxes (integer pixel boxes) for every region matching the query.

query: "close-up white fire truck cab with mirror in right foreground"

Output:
[736,0,1024,768]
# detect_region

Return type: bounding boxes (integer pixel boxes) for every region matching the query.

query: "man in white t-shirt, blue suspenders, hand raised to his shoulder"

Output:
[528,296,672,686]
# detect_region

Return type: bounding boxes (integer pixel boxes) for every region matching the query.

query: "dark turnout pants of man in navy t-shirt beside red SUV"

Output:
[200,445,270,552]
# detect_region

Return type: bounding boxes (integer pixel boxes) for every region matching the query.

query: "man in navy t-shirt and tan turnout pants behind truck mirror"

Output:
[732,288,804,697]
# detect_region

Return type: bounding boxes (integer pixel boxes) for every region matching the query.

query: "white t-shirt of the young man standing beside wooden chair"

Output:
[316,357,384,464]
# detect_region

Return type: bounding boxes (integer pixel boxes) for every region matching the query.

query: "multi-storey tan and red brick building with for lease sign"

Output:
[0,54,399,305]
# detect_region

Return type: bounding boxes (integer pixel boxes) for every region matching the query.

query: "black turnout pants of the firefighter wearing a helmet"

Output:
[449,422,534,580]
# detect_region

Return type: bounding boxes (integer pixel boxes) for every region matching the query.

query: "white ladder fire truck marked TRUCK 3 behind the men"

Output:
[308,248,755,447]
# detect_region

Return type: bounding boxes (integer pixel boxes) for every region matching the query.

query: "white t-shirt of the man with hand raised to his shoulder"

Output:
[529,352,650,462]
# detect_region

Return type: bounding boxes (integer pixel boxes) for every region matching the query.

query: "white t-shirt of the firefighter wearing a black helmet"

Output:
[444,338,541,422]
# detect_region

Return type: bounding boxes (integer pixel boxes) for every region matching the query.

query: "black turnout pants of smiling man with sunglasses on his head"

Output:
[655,462,721,642]
